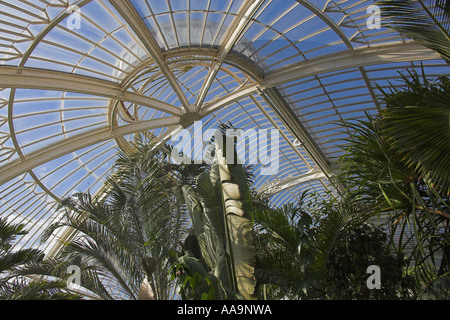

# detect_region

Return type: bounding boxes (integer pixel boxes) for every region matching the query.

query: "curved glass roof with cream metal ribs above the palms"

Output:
[0,0,450,253]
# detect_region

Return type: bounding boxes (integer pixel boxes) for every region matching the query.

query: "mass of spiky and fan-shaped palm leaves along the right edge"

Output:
[339,73,450,293]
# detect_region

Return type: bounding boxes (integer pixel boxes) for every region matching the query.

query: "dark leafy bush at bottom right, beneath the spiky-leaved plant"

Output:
[321,223,416,300]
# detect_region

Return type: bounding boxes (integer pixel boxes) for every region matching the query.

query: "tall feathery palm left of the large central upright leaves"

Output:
[44,139,195,299]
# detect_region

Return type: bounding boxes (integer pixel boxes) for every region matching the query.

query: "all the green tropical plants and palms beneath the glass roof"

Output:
[0,0,450,299]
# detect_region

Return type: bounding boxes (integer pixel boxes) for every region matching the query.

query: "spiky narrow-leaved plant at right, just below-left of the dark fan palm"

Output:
[338,110,450,300]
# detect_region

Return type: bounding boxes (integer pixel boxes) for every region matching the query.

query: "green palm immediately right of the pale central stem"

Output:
[255,190,361,299]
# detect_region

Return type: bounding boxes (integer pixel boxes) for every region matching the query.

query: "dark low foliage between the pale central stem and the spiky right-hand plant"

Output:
[255,191,415,299]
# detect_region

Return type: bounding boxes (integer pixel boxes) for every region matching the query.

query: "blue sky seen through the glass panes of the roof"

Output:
[0,0,448,254]
